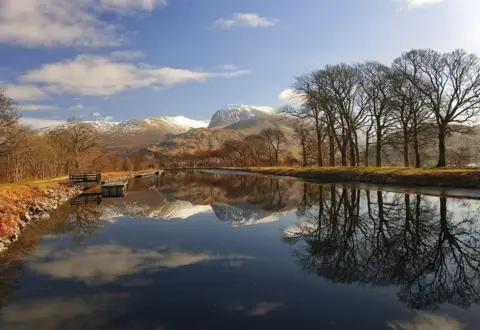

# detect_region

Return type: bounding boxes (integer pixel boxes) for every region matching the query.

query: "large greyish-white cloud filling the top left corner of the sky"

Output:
[0,0,166,47]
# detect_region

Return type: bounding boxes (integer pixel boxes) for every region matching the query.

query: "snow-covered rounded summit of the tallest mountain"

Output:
[208,104,276,128]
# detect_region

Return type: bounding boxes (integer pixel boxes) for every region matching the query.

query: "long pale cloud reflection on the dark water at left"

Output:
[28,244,253,284]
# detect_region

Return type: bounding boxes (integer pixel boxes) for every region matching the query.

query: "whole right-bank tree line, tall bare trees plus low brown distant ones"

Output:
[157,49,480,168]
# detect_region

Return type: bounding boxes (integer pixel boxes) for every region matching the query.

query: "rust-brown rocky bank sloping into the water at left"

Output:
[0,186,82,252]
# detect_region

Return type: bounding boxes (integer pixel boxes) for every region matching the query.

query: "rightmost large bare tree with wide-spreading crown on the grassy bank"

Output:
[393,49,480,167]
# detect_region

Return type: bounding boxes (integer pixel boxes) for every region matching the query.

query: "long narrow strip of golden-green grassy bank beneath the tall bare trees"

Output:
[218,167,480,189]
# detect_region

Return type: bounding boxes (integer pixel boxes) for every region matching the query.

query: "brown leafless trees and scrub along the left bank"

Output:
[0,89,153,182]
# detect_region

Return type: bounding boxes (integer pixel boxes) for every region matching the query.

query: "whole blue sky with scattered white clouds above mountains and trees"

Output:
[0,0,480,127]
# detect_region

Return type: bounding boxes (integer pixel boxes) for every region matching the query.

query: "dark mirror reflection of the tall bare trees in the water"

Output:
[284,184,480,309]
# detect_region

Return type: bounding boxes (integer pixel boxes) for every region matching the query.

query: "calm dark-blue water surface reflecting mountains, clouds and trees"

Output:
[0,172,480,330]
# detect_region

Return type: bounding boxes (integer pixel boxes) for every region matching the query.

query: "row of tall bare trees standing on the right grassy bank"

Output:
[282,49,480,167]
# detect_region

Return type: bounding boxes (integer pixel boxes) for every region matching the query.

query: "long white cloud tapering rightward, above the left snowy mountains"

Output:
[20,55,249,96]
